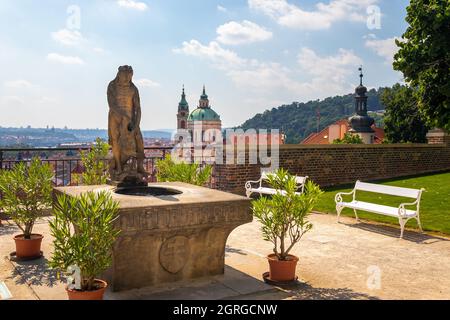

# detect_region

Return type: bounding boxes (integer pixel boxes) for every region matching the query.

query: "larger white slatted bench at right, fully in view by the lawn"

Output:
[335,180,425,238]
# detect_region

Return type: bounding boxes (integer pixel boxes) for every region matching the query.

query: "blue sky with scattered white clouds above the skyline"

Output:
[0,0,408,129]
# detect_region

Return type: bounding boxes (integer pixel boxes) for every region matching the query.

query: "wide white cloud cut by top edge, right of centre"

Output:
[248,0,379,30]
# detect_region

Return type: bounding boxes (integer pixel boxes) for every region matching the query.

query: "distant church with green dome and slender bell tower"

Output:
[177,86,222,140]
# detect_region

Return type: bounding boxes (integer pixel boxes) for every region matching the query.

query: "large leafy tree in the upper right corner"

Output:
[394,0,450,130]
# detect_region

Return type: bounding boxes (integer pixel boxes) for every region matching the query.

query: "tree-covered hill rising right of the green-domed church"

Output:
[240,88,384,143]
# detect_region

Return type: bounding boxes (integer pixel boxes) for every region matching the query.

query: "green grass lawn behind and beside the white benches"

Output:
[315,172,450,234]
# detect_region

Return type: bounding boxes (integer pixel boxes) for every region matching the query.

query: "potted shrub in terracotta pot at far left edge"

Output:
[0,157,53,259]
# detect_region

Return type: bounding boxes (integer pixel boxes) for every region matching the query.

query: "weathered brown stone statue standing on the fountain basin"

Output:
[107,65,145,175]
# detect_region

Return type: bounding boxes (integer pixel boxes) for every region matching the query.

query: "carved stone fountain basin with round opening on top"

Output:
[55,182,252,291]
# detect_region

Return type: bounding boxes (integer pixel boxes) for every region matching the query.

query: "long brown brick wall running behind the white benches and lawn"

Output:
[215,136,450,194]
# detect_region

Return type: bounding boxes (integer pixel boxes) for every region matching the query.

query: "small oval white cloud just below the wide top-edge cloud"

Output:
[217,20,272,45]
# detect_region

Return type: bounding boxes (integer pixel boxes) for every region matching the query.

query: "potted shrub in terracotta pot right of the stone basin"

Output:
[252,169,322,282]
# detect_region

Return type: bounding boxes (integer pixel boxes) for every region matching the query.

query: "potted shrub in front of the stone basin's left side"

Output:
[49,191,119,300]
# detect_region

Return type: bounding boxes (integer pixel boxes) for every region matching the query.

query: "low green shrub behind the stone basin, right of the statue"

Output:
[156,155,212,186]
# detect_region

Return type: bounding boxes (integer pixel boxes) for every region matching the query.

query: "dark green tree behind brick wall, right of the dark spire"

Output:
[381,83,429,143]
